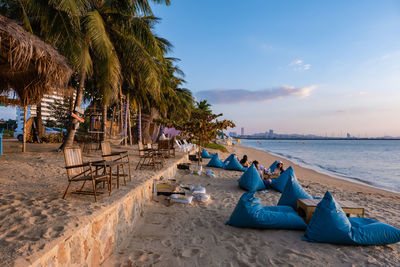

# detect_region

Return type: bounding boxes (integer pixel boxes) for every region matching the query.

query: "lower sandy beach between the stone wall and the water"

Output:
[102,146,400,266]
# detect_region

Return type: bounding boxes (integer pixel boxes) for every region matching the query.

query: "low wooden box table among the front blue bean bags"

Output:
[297,198,364,223]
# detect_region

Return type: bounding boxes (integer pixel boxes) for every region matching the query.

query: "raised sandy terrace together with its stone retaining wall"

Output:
[0,141,187,266]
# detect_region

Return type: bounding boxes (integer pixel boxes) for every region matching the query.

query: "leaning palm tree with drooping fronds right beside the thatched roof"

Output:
[0,0,170,148]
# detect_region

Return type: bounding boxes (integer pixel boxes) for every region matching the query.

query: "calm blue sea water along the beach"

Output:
[242,139,400,192]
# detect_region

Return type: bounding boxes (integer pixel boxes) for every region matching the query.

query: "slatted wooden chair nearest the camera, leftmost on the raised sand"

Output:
[63,147,111,202]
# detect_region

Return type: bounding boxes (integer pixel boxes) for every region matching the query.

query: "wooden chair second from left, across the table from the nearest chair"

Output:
[101,141,132,191]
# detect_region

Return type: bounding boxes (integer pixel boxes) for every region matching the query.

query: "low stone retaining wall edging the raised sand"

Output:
[22,156,187,267]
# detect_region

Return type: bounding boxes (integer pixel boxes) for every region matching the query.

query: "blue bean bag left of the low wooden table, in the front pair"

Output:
[226,192,307,230]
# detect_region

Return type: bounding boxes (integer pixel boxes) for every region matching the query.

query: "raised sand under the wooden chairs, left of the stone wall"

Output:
[0,140,183,266]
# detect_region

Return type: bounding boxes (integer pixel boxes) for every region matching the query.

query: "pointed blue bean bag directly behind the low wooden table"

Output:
[278,175,312,210]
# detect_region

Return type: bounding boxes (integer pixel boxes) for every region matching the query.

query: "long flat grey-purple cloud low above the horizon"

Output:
[196,85,317,104]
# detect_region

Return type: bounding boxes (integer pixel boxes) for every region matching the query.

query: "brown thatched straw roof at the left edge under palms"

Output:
[0,15,72,105]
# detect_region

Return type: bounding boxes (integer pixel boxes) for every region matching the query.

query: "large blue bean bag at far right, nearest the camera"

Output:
[303,191,400,245]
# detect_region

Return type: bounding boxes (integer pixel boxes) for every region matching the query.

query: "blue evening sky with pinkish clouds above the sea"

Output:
[149,0,400,137]
